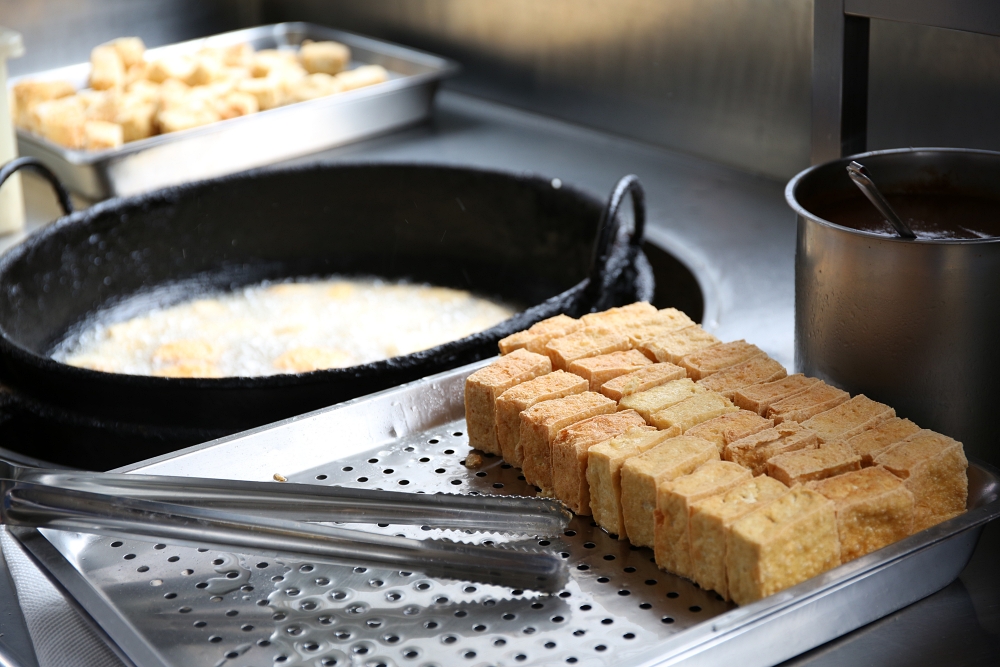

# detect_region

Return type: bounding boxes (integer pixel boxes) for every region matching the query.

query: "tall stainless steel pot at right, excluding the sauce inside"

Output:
[785,148,1000,462]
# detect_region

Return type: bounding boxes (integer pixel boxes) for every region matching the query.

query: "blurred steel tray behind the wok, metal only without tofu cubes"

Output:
[11,23,458,199]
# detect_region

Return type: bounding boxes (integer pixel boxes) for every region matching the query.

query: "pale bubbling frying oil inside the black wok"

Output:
[52,279,514,378]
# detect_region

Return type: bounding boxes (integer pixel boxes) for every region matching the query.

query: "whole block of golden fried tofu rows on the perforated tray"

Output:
[465,303,968,604]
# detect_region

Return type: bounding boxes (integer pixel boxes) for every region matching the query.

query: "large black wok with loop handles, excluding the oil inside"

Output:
[0,158,653,467]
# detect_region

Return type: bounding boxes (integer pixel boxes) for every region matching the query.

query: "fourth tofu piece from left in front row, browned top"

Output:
[552,410,646,516]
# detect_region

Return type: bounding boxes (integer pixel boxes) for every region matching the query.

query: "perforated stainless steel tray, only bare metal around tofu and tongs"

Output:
[13,362,1000,667]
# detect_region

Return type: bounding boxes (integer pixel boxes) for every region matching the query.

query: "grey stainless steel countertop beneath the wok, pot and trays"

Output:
[0,92,1000,667]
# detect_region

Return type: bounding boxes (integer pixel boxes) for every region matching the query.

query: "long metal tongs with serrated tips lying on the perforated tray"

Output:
[0,459,569,591]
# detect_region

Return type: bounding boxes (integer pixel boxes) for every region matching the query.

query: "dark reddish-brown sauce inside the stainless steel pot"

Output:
[809,192,1000,239]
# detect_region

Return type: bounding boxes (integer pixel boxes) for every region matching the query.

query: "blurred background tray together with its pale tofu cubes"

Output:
[9,23,457,200]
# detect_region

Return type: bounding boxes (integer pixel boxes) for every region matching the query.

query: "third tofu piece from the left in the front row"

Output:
[524,392,617,496]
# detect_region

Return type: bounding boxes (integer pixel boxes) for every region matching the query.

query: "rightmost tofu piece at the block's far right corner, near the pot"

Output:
[875,430,969,532]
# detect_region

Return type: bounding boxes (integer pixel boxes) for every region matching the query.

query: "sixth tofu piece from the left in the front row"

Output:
[621,435,719,547]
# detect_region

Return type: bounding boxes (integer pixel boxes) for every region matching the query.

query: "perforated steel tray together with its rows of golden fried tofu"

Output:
[13,307,1000,667]
